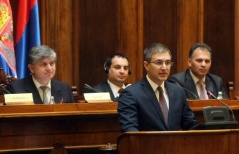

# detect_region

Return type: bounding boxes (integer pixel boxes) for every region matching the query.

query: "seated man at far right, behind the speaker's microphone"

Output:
[168,43,227,99]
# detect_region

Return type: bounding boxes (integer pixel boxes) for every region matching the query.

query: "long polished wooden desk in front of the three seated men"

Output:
[0,100,239,152]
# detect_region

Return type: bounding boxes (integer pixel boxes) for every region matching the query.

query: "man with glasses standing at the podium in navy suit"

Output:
[118,43,203,132]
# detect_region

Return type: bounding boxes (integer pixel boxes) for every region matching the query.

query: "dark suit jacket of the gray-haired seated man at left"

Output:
[6,76,74,104]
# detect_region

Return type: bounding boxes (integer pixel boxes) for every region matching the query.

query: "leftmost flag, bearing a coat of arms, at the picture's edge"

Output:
[0,0,17,77]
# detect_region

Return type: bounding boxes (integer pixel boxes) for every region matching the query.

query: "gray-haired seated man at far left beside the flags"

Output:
[6,45,74,104]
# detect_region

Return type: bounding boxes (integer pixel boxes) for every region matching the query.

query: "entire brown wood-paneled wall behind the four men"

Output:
[11,0,239,93]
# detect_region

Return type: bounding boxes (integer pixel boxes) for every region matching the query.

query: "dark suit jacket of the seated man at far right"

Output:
[168,69,228,99]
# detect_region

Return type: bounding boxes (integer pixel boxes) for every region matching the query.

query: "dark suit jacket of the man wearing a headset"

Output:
[87,81,118,102]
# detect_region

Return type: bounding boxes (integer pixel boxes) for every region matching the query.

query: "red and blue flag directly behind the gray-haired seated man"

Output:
[15,0,41,78]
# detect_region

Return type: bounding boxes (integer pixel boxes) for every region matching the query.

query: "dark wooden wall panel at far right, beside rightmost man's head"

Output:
[204,0,235,88]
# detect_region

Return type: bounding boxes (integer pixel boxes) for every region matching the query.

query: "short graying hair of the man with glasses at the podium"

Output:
[144,43,172,62]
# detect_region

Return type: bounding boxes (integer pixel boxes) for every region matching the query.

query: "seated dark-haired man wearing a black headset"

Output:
[88,53,131,102]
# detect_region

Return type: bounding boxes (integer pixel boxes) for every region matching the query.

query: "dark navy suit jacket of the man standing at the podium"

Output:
[118,77,200,132]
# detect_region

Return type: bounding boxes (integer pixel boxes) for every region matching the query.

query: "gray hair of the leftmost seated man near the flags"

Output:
[28,45,57,64]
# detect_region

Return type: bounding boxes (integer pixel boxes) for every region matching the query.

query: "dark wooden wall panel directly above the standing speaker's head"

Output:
[143,0,178,73]
